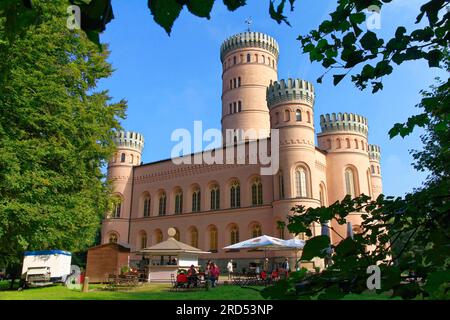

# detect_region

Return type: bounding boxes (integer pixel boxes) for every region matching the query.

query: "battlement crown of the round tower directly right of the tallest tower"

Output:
[267,78,315,108]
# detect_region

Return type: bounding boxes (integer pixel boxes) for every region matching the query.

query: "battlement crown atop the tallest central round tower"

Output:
[220,31,280,62]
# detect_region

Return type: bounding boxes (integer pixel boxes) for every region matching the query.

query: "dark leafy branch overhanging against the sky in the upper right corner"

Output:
[298,0,450,93]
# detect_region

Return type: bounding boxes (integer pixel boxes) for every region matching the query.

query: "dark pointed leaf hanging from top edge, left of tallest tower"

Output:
[148,0,184,35]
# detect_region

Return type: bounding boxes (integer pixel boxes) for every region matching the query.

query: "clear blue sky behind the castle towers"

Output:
[96,0,442,195]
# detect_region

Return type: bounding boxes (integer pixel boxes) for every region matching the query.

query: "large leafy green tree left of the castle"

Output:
[0,1,126,272]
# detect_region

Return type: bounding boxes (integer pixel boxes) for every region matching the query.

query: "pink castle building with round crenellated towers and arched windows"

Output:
[102,32,382,268]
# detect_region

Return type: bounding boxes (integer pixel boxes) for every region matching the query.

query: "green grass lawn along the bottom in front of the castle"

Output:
[0,283,394,300]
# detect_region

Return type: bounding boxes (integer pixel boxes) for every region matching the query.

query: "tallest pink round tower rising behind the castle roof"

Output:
[220,32,279,144]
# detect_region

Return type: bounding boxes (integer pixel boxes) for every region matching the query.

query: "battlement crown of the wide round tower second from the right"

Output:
[320,112,369,137]
